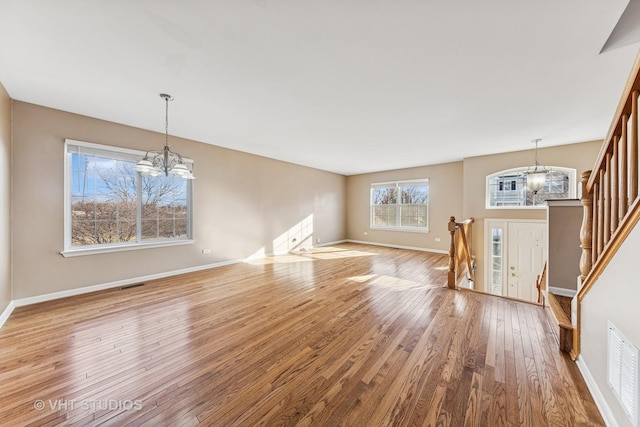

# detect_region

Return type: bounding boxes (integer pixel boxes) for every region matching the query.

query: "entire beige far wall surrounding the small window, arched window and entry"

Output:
[347,141,602,289]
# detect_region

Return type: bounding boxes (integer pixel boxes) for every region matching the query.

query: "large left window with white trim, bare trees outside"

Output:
[65,140,192,252]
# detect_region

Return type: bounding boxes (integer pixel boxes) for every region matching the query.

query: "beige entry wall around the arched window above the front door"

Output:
[462,141,602,289]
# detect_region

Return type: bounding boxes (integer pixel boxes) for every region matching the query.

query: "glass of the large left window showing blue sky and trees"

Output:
[70,153,189,246]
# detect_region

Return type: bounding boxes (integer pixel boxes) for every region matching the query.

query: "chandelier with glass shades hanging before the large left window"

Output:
[135,93,196,179]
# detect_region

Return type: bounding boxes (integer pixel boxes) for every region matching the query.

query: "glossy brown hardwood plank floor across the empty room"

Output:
[0,244,604,426]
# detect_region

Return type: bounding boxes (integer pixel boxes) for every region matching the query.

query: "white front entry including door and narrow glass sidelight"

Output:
[485,219,547,302]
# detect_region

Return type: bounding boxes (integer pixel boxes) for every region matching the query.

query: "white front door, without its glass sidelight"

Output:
[506,222,547,302]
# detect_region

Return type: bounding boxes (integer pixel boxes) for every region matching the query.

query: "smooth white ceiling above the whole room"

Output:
[0,0,639,175]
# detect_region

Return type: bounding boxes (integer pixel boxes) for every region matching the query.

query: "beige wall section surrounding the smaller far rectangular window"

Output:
[347,162,462,251]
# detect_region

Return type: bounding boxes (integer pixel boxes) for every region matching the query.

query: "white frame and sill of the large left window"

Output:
[60,139,195,257]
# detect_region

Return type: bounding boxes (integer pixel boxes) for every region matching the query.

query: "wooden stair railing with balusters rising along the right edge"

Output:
[571,52,640,358]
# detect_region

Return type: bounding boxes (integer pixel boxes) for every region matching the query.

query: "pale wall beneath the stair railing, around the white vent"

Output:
[580,225,640,426]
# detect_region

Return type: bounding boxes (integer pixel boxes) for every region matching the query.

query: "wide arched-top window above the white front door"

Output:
[486,166,576,209]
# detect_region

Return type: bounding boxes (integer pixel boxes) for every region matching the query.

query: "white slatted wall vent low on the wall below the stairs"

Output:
[607,322,640,427]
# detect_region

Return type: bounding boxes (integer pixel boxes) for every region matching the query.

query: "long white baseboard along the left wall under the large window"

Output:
[12,259,245,307]
